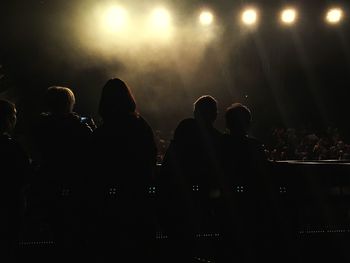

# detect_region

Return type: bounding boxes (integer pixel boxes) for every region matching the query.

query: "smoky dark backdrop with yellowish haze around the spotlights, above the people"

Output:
[0,0,350,140]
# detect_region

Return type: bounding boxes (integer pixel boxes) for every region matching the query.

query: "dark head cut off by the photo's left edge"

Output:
[0,100,17,134]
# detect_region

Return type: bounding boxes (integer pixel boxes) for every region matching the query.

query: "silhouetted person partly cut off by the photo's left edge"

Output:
[0,100,29,262]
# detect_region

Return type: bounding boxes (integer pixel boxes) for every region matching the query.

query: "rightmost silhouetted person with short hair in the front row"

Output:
[221,103,270,262]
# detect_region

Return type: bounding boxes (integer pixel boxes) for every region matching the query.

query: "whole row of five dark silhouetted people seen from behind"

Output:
[0,78,304,262]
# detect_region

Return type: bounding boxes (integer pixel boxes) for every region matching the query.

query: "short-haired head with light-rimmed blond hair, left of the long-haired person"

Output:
[45,86,75,115]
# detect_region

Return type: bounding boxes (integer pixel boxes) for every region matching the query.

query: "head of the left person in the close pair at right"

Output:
[193,95,218,124]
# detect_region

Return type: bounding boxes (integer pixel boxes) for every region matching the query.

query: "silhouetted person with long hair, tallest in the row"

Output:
[90,78,157,262]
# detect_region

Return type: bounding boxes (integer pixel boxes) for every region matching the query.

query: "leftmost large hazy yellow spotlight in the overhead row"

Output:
[104,6,128,31]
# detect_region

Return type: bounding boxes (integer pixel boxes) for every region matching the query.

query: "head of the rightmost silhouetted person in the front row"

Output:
[225,103,252,135]
